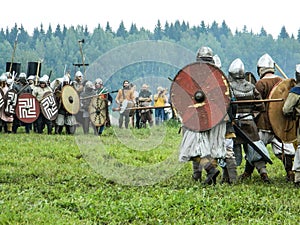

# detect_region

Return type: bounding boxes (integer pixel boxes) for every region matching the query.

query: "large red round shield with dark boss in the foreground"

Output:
[170,62,230,131]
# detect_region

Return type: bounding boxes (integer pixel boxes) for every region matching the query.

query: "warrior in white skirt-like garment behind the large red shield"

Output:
[179,46,226,185]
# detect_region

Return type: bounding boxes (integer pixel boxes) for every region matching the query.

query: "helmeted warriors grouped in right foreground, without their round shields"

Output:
[179,46,300,187]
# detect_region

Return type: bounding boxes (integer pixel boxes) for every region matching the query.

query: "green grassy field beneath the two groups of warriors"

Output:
[0,123,300,224]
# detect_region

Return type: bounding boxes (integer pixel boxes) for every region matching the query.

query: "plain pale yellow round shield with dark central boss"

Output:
[61,85,80,115]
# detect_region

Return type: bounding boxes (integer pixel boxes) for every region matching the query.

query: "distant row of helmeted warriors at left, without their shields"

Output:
[0,71,112,135]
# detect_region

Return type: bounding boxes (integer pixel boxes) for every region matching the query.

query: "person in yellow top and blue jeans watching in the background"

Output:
[154,86,168,125]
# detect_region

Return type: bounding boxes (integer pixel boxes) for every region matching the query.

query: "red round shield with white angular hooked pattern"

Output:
[16,93,40,123]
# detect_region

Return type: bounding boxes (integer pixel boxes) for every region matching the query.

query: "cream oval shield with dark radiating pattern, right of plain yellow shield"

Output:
[88,96,108,127]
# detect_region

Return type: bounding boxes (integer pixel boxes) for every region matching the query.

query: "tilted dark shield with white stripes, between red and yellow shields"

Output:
[40,92,58,121]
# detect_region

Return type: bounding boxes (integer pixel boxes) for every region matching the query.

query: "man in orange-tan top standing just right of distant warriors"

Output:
[116,80,134,129]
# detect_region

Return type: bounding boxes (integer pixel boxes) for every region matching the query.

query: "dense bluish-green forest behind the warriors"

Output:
[0,20,300,89]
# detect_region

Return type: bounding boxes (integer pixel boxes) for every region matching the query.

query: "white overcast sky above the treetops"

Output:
[0,0,300,38]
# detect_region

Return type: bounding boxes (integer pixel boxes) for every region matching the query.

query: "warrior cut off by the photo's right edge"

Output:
[282,64,300,188]
